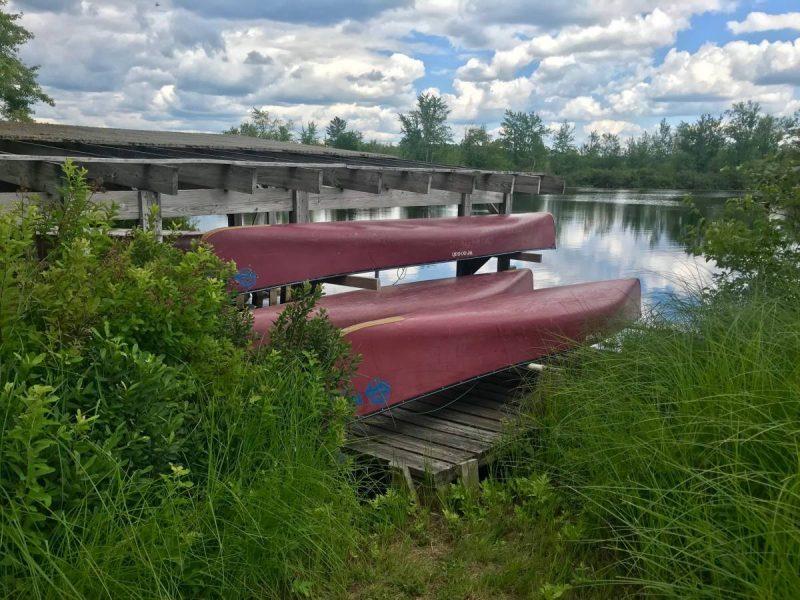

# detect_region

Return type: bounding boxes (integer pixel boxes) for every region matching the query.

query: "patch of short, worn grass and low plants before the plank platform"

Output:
[347,474,626,600]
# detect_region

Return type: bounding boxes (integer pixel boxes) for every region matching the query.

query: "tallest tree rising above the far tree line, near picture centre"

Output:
[399,94,453,162]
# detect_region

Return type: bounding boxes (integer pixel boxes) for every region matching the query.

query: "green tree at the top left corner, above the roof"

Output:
[0,0,53,121]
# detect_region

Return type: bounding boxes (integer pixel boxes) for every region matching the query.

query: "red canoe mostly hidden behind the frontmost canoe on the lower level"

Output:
[253,269,533,338]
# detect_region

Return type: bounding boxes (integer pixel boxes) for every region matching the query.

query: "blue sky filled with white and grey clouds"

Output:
[6,0,800,142]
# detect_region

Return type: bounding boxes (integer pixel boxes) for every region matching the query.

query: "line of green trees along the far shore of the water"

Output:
[225,94,800,189]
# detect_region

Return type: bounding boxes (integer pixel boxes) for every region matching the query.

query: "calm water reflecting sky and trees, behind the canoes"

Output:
[199,190,726,304]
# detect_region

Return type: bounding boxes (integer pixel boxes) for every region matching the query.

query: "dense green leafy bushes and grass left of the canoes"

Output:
[0,164,356,598]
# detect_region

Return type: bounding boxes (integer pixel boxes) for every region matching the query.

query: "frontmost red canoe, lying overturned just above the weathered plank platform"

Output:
[343,279,641,416]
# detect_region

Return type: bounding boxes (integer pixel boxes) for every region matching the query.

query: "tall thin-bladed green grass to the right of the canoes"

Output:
[536,297,800,598]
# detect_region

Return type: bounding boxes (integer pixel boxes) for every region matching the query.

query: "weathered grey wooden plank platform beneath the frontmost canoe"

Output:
[347,370,530,487]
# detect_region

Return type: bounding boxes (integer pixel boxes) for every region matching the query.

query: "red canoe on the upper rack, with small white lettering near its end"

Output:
[203,213,556,291]
